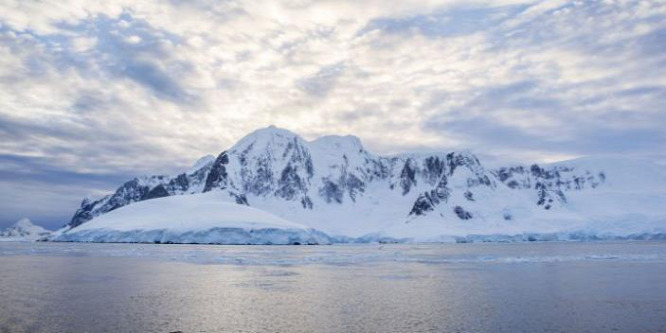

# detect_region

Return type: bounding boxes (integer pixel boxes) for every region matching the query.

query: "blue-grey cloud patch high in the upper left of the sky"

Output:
[25,13,195,103]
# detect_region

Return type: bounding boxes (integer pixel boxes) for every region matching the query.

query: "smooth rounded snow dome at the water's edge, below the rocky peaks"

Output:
[52,192,330,244]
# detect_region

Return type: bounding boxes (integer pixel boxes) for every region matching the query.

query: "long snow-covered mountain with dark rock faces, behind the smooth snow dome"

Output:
[55,126,666,240]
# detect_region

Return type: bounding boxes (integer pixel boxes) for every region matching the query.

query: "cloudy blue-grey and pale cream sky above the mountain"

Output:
[0,0,666,228]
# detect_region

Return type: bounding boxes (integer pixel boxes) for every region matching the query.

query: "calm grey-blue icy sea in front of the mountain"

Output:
[0,241,666,333]
